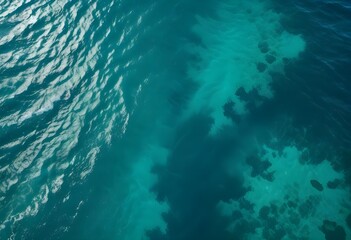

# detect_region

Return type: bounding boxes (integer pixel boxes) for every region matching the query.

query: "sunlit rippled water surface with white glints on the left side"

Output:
[0,0,141,235]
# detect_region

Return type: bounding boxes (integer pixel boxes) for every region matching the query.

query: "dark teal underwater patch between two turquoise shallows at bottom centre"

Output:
[149,116,246,240]
